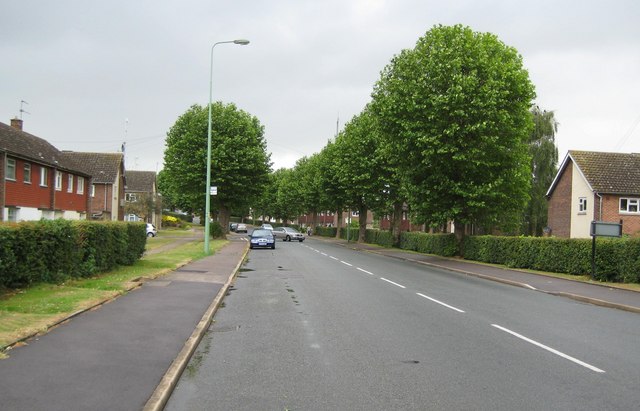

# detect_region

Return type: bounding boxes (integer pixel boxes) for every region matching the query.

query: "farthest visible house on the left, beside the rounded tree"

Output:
[125,170,162,227]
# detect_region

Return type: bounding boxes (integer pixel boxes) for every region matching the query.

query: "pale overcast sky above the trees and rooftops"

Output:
[0,0,640,171]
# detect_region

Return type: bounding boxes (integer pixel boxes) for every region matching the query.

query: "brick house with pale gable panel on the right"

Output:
[546,150,640,238]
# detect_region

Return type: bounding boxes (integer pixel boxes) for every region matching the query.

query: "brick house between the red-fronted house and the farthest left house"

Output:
[63,151,125,221]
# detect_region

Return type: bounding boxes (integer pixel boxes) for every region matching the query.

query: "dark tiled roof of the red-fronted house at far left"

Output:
[0,123,90,176]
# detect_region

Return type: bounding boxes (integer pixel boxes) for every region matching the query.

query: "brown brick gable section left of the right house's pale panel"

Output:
[547,162,573,238]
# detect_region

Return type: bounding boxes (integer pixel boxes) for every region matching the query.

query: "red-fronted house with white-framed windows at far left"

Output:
[0,119,91,221]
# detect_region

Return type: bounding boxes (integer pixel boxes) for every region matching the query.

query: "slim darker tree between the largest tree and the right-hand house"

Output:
[522,106,558,236]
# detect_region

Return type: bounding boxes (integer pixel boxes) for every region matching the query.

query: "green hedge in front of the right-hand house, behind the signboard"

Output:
[463,236,640,283]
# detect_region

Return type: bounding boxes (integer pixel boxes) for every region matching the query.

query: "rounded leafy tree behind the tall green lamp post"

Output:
[164,102,271,227]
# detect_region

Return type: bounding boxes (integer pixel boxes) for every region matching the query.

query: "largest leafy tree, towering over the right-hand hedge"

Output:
[372,25,535,235]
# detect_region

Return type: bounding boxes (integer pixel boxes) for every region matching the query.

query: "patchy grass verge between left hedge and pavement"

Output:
[0,238,227,350]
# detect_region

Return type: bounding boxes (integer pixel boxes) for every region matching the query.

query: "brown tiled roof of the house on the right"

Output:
[547,150,640,196]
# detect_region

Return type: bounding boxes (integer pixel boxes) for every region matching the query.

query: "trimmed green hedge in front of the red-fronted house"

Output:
[0,219,147,288]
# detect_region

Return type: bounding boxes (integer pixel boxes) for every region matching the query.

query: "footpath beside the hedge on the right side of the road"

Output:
[312,237,640,313]
